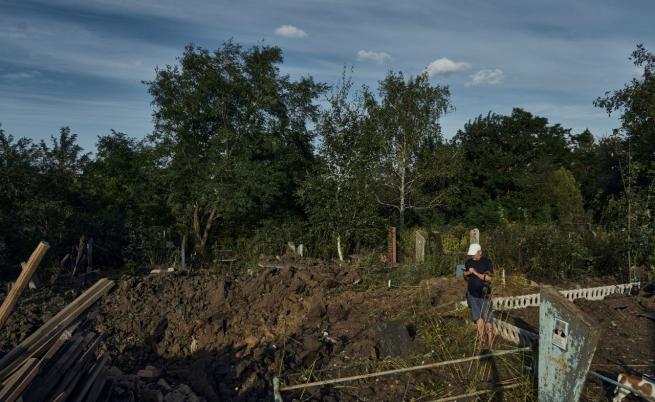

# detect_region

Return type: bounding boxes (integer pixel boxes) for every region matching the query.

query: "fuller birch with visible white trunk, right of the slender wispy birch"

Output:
[367,72,456,228]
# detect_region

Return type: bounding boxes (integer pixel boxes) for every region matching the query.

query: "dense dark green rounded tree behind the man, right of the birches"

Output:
[455,109,570,220]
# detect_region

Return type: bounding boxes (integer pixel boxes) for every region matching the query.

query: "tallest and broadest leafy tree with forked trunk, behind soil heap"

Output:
[147,42,325,255]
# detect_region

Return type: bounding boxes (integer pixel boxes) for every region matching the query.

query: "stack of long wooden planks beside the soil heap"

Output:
[0,278,114,402]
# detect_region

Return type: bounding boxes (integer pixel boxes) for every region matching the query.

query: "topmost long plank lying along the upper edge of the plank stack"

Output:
[0,278,114,379]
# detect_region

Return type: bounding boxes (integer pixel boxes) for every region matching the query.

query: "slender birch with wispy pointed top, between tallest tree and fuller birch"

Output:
[299,70,382,261]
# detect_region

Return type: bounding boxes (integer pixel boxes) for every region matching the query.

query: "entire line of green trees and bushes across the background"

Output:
[0,42,655,282]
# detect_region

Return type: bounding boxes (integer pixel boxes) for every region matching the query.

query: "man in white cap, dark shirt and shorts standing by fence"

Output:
[464,243,494,348]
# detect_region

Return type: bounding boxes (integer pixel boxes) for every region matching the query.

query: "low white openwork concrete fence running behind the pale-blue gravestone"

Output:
[457,282,640,310]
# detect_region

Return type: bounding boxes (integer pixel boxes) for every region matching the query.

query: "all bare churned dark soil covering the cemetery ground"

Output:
[0,259,644,402]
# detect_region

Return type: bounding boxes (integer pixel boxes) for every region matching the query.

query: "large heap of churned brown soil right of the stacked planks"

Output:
[97,260,363,400]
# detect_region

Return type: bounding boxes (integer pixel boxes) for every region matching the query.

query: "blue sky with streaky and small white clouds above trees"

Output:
[0,0,655,151]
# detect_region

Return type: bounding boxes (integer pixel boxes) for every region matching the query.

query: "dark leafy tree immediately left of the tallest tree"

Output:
[83,130,173,265]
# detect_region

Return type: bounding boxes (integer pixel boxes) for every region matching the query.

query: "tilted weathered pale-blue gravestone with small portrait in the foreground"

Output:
[538,286,600,402]
